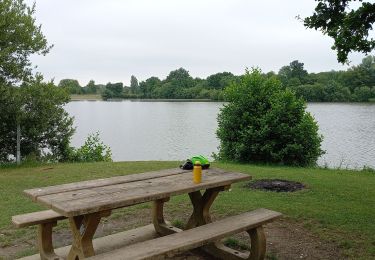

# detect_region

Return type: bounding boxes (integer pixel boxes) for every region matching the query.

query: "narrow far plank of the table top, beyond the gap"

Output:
[24,168,187,201]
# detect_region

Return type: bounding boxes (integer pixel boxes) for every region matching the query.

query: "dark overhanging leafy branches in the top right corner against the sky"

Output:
[303,0,375,63]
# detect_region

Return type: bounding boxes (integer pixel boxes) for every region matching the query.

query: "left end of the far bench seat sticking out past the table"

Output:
[12,210,66,228]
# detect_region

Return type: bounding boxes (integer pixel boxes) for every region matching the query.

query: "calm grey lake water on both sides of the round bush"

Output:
[66,101,375,168]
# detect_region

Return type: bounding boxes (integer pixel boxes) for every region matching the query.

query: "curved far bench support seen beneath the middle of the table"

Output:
[152,198,182,236]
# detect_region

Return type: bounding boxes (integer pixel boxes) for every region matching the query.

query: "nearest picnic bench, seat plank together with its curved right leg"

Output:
[89,209,281,260]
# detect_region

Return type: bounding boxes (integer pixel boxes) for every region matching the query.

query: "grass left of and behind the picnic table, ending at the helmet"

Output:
[0,162,177,228]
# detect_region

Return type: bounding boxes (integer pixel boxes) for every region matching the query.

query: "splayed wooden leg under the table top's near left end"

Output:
[67,211,111,260]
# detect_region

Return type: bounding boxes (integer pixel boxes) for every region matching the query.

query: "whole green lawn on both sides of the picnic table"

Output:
[0,162,375,259]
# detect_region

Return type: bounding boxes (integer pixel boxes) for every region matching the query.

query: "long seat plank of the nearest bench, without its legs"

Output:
[89,209,281,260]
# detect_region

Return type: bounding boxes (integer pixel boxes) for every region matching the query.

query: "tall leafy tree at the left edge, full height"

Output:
[0,0,74,162]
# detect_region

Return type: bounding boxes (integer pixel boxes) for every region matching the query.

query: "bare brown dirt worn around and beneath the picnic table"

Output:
[0,205,345,260]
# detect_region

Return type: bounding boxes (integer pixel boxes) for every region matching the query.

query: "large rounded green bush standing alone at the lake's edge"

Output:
[217,69,323,166]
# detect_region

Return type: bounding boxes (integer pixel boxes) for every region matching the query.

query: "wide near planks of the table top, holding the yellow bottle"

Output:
[37,170,251,217]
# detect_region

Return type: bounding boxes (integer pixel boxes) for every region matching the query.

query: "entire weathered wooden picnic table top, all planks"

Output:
[24,168,251,217]
